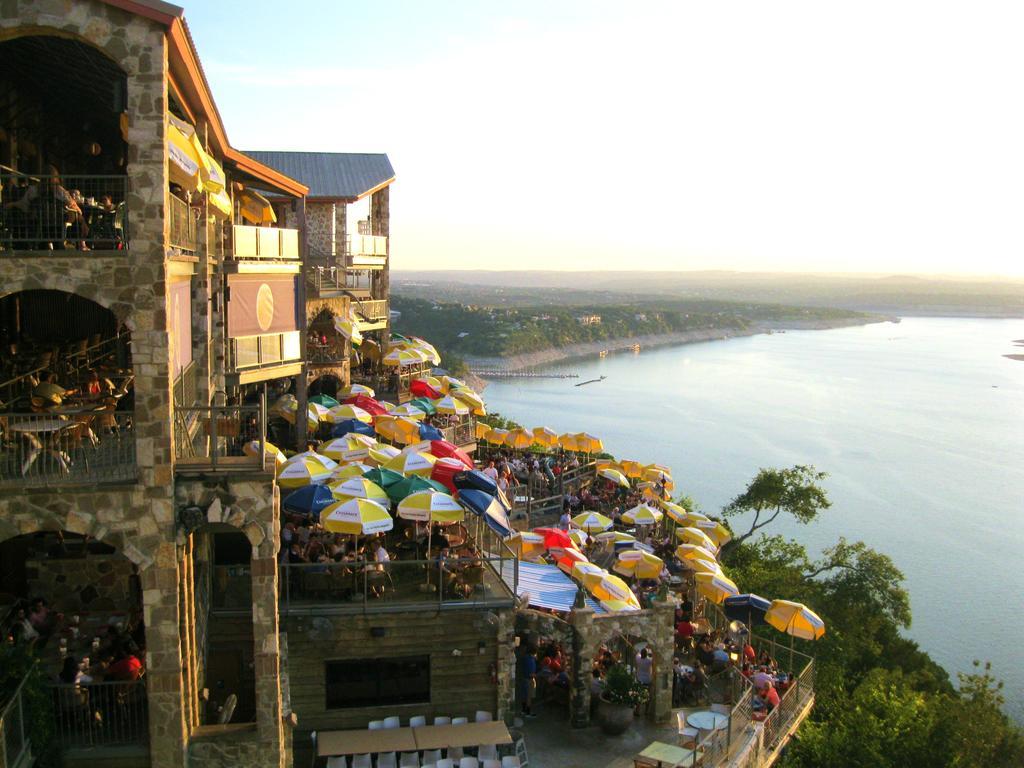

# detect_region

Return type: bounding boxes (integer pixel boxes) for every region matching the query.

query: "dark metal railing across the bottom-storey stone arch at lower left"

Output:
[50,679,150,748]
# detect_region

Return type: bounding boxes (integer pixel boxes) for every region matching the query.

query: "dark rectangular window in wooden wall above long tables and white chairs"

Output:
[324,655,430,710]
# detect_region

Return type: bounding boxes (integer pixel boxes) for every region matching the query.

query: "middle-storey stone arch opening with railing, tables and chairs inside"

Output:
[0,290,135,486]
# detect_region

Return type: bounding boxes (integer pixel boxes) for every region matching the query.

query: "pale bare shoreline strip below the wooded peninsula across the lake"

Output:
[465,316,896,381]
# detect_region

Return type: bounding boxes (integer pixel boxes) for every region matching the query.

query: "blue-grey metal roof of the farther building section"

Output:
[245,151,394,201]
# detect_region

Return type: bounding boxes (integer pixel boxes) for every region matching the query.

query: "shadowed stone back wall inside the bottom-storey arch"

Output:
[25,554,141,613]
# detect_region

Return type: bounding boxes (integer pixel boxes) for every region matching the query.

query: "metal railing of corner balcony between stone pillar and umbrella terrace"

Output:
[174,403,266,471]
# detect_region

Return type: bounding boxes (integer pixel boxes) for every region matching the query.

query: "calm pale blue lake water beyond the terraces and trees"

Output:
[485,318,1024,721]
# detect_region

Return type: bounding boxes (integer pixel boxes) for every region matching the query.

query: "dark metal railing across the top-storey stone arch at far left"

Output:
[0,173,129,255]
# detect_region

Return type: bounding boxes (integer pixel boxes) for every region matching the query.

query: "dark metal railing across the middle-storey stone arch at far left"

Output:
[0,406,136,487]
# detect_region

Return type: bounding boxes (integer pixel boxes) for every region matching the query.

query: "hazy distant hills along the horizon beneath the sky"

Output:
[391,269,1024,317]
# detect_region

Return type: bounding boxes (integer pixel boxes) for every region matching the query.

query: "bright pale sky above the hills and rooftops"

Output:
[184,0,1024,275]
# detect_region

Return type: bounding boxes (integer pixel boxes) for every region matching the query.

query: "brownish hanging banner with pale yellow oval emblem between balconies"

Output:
[227,274,300,339]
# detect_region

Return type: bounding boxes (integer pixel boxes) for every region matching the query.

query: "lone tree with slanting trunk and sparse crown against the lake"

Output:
[722,465,831,548]
